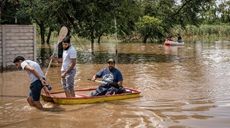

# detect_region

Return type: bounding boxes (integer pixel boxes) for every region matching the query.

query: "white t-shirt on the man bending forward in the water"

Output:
[21,60,45,83]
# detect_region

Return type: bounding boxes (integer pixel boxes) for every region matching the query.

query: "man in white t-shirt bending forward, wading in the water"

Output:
[13,56,49,110]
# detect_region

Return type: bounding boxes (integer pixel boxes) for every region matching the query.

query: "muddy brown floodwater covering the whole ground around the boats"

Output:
[0,41,230,128]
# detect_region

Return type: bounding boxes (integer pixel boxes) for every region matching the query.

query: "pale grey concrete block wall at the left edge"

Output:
[0,25,36,70]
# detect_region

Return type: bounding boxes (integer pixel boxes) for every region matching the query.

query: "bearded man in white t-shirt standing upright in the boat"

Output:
[51,37,77,97]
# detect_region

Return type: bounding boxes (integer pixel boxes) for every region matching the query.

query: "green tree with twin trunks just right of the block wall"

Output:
[20,0,62,44]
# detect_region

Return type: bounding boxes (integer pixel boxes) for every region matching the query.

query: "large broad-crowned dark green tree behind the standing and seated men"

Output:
[52,0,140,50]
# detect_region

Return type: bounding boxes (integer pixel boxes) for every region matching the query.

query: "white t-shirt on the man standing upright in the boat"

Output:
[61,46,77,72]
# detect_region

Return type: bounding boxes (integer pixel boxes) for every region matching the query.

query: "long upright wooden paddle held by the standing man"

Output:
[45,26,68,78]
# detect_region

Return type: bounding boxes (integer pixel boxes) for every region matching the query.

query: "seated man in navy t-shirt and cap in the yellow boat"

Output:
[91,59,125,96]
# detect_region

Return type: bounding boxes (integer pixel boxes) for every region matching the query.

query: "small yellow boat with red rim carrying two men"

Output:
[41,88,141,105]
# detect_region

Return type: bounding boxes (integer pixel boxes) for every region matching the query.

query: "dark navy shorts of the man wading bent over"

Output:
[29,80,43,101]
